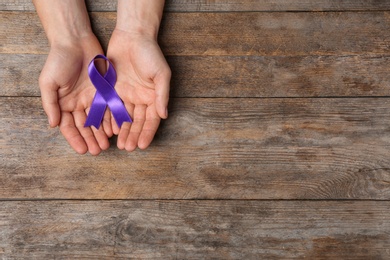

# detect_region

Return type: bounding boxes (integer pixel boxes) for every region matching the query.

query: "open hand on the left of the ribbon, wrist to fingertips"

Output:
[39,33,113,155]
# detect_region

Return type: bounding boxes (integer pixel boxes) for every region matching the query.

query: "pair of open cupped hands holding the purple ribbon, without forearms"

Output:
[39,29,171,155]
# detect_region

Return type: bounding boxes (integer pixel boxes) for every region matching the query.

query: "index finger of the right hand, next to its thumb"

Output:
[138,106,161,149]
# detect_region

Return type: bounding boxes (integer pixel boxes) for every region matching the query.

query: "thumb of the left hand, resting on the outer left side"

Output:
[39,75,61,127]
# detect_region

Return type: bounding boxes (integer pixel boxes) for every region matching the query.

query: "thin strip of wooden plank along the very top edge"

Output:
[0,0,390,12]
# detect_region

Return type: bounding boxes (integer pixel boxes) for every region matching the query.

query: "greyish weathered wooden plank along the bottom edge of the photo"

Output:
[0,201,390,259]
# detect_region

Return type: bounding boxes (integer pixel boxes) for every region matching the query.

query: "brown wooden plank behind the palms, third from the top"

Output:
[0,54,390,97]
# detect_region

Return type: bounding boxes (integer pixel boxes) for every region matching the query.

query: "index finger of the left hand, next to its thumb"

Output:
[59,112,88,154]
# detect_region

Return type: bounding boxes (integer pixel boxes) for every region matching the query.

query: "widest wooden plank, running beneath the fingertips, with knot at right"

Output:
[0,98,390,200]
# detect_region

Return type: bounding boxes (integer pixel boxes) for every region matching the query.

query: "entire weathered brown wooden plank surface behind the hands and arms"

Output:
[0,0,390,259]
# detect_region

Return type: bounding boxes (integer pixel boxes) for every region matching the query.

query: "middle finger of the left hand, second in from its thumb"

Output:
[72,111,101,155]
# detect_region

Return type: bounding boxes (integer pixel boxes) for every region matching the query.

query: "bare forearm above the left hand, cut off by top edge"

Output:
[33,0,92,45]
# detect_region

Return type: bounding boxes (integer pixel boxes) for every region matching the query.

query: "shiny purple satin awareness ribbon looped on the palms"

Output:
[84,55,132,128]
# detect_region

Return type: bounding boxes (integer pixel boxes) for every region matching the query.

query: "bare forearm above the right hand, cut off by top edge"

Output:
[116,0,164,38]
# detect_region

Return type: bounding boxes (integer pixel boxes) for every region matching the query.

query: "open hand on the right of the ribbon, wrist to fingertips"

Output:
[107,30,170,151]
